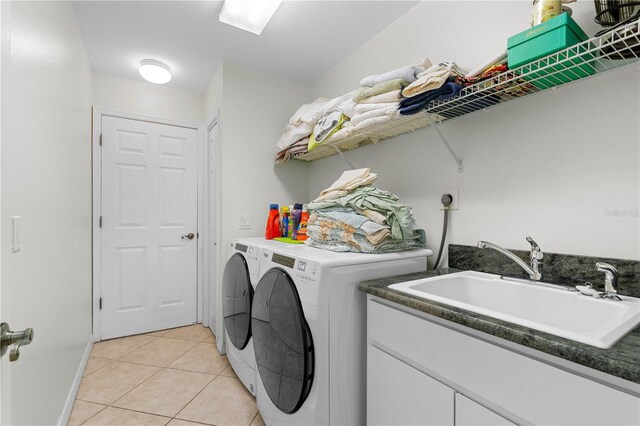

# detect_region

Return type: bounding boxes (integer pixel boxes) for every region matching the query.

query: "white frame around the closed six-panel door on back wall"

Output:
[91,107,208,342]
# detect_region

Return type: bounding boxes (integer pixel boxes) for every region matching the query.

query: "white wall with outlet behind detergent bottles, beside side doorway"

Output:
[204,62,309,340]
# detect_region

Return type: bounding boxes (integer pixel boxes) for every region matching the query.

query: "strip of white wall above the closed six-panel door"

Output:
[93,73,203,123]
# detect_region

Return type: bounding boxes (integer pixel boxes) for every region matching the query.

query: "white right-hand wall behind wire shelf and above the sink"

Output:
[309,1,640,259]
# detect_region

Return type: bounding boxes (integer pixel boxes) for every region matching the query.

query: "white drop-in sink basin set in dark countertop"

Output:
[389,271,640,349]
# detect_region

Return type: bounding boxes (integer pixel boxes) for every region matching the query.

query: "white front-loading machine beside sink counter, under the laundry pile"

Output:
[251,246,433,425]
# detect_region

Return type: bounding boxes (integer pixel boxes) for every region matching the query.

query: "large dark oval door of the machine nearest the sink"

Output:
[251,268,314,414]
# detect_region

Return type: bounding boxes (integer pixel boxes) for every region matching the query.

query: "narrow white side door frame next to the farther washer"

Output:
[208,113,224,342]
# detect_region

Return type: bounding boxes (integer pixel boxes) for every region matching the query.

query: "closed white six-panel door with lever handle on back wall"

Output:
[101,116,197,339]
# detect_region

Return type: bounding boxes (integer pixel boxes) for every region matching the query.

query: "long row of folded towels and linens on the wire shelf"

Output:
[276,54,510,163]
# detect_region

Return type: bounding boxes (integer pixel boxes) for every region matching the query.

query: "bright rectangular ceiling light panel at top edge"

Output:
[218,0,282,35]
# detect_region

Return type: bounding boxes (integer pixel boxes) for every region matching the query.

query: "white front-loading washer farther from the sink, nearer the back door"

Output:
[222,238,290,395]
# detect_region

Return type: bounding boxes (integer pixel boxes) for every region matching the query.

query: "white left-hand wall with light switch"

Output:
[0,2,91,425]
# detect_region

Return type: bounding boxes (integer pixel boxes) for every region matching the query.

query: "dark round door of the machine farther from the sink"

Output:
[222,253,253,349]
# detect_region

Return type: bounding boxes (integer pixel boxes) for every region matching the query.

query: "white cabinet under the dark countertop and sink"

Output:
[367,296,640,426]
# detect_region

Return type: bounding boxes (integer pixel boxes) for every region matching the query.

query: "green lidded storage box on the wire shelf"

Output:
[507,13,595,89]
